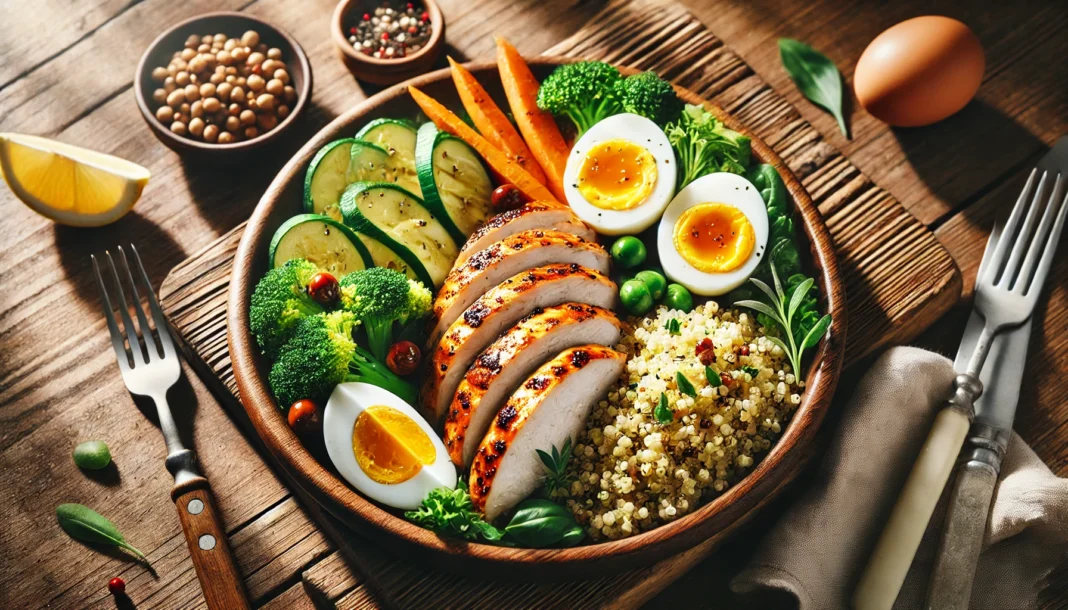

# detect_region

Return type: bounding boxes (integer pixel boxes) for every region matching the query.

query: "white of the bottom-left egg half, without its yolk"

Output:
[323,382,456,511]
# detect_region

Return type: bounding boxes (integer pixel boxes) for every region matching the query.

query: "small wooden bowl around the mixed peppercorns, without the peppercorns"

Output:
[330,0,445,84]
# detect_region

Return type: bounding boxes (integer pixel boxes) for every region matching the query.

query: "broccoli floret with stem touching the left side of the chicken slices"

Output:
[341,267,430,361]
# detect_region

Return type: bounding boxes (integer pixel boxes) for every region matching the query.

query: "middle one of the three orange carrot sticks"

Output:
[449,58,546,184]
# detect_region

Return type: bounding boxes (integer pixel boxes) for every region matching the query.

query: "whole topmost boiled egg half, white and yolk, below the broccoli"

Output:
[564,114,675,235]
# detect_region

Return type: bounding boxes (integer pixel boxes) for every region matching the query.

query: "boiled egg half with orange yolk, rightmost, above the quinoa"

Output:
[657,172,768,296]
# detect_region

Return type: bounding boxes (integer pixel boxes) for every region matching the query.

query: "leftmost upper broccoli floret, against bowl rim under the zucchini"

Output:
[249,259,323,359]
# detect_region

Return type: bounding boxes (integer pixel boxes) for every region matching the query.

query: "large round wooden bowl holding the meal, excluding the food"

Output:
[226,58,846,580]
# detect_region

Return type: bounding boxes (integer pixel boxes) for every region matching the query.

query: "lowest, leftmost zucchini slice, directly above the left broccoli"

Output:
[268,214,374,273]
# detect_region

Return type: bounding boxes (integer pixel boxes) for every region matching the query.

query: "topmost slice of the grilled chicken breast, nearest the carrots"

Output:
[455,201,597,267]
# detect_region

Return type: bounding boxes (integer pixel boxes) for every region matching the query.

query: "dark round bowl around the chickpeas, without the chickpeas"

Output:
[134,12,312,161]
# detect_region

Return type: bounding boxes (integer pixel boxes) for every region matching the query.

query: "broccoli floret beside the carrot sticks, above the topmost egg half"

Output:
[537,61,622,136]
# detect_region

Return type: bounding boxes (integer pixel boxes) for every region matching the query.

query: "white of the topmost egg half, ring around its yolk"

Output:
[564,113,675,235]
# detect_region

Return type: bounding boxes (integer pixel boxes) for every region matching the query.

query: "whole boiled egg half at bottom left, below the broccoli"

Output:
[323,382,456,511]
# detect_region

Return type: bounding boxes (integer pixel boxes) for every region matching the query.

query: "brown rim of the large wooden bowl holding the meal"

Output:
[226,56,847,578]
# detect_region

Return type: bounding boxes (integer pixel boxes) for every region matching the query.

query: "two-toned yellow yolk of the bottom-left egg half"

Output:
[352,406,437,485]
